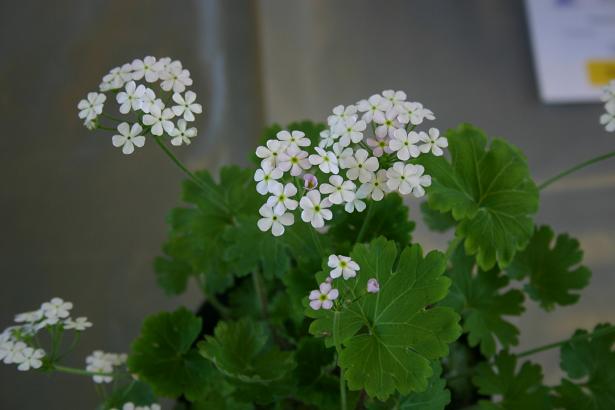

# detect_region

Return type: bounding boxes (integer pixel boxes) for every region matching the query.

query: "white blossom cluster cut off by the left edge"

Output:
[0,298,92,371]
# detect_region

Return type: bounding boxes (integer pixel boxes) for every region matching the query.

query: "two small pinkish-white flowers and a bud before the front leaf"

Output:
[308,255,380,310]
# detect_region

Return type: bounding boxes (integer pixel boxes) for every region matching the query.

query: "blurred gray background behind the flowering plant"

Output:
[0,0,615,409]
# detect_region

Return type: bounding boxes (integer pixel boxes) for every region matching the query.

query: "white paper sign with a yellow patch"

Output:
[525,0,615,103]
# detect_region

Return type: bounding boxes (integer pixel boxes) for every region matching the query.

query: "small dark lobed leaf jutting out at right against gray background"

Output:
[508,226,591,310]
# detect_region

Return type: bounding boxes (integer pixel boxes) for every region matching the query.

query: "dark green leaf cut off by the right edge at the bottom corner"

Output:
[555,324,615,410]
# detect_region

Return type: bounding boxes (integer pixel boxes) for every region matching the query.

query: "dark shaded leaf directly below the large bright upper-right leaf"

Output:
[443,247,524,357]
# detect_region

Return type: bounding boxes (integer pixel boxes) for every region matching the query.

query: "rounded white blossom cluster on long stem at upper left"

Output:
[77,56,203,154]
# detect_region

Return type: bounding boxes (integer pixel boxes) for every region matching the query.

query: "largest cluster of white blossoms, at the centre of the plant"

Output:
[254,90,448,236]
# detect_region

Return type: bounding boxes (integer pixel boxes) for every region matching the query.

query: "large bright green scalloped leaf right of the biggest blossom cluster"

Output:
[417,124,538,270]
